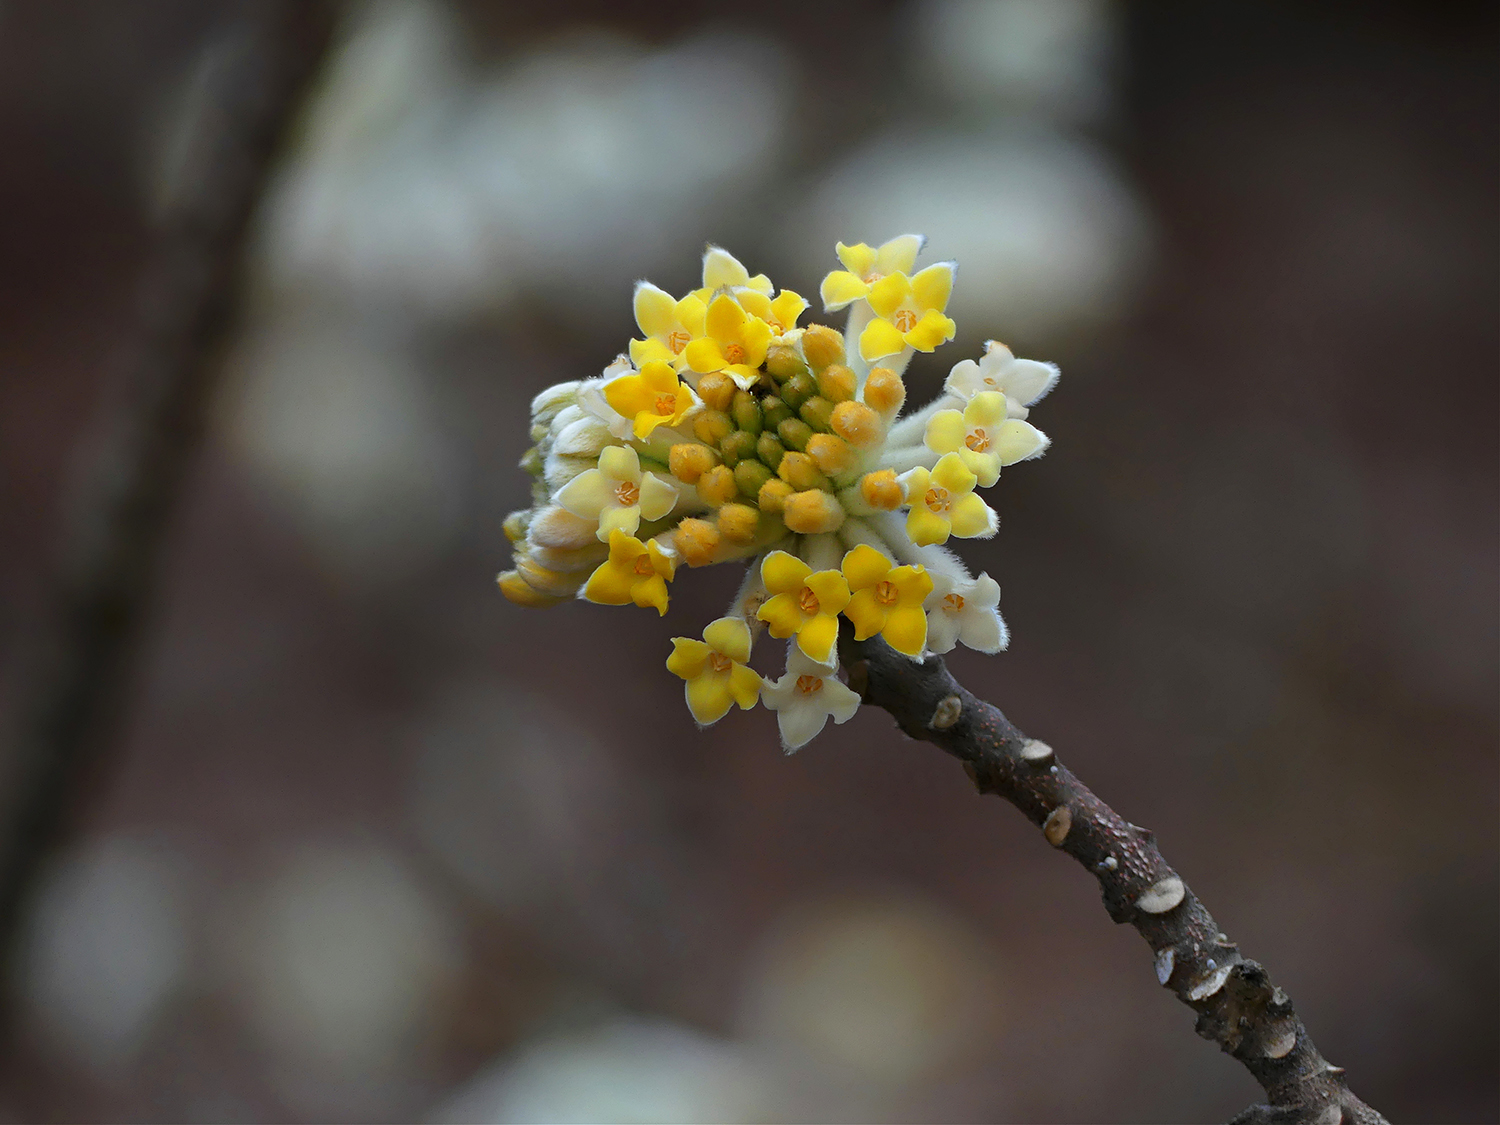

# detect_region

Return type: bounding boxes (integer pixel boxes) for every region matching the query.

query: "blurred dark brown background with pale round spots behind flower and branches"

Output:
[0,0,1500,1122]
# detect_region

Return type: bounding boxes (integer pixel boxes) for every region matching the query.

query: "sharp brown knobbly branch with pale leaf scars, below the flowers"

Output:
[840,629,1386,1125]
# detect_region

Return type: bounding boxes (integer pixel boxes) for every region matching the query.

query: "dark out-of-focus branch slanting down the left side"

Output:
[0,0,335,1014]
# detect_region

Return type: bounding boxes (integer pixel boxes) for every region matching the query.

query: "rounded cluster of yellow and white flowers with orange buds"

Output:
[500,234,1058,750]
